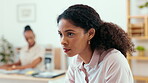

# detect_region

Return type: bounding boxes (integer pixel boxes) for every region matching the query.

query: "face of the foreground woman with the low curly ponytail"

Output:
[58,19,90,57]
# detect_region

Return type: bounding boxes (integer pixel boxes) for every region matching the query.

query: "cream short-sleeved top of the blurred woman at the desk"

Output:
[19,44,45,70]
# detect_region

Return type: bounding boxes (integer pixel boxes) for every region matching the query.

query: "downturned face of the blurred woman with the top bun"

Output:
[24,31,35,47]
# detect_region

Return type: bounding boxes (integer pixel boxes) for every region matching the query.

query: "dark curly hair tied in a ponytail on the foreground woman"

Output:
[57,4,134,57]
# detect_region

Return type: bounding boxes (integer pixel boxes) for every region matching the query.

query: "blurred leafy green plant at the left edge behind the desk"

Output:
[0,37,14,65]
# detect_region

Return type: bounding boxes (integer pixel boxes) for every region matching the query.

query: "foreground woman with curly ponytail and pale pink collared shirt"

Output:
[57,4,133,83]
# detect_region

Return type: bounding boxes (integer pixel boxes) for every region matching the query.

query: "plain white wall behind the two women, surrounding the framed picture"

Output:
[0,0,126,46]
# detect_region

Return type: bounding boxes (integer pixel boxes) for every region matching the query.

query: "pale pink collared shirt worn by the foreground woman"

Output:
[65,49,133,83]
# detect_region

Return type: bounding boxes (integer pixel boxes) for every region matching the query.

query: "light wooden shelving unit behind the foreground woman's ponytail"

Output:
[127,0,148,83]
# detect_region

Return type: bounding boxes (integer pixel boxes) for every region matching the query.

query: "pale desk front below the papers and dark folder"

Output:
[0,71,65,83]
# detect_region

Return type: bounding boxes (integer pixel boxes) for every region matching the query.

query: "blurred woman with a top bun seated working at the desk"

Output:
[0,25,45,70]
